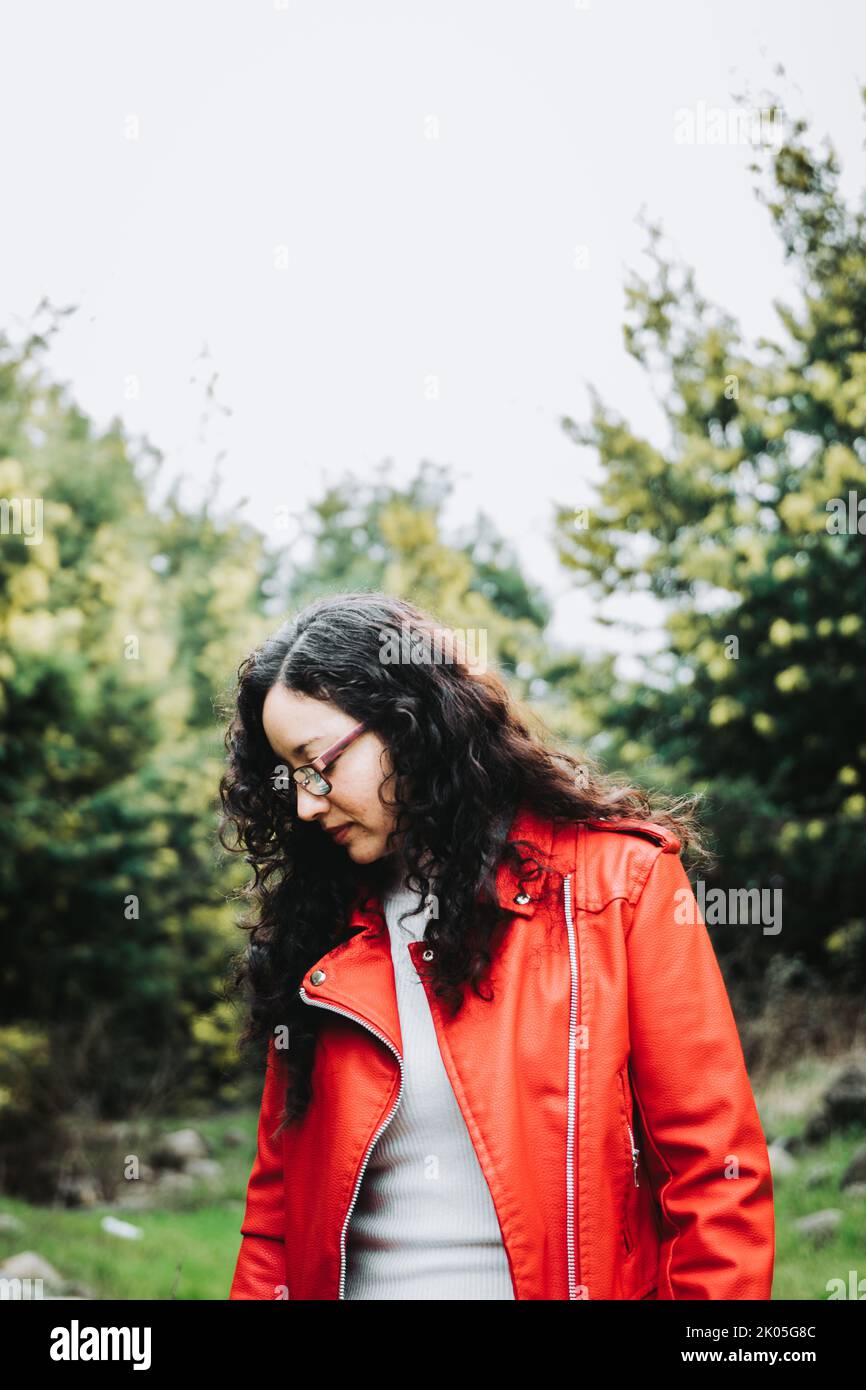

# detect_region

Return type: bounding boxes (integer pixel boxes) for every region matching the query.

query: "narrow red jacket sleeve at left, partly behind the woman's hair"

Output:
[228,1038,288,1300]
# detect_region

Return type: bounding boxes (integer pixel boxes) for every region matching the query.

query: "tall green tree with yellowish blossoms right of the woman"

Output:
[555,92,866,980]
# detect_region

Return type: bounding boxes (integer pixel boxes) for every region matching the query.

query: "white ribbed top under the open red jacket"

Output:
[345,876,514,1300]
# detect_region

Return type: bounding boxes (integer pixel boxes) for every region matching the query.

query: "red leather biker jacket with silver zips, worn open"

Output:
[229,812,774,1300]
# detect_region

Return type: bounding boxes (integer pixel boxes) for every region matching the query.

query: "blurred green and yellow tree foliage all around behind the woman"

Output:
[0,92,866,1223]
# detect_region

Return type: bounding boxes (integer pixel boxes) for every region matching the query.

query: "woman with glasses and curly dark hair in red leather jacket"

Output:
[221,594,774,1300]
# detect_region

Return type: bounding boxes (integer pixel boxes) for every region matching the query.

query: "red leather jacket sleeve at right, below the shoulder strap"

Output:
[626,851,776,1300]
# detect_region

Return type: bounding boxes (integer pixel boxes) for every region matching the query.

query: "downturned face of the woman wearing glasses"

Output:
[261,685,395,865]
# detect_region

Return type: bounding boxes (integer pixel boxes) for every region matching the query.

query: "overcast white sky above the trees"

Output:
[0,0,866,672]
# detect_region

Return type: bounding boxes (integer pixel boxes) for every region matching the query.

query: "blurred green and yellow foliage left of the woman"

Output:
[0,319,270,1194]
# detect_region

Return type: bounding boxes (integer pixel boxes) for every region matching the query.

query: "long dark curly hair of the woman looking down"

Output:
[218,591,709,1125]
